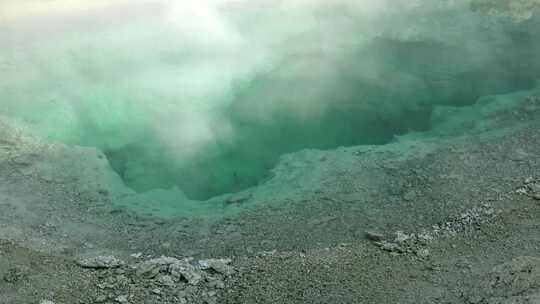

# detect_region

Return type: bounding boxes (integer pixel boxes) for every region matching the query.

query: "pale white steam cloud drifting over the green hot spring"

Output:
[0,0,528,200]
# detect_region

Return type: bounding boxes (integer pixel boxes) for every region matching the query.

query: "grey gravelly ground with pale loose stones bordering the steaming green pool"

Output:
[0,91,540,304]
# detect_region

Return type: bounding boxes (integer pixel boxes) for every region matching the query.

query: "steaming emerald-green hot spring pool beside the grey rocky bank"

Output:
[0,1,540,200]
